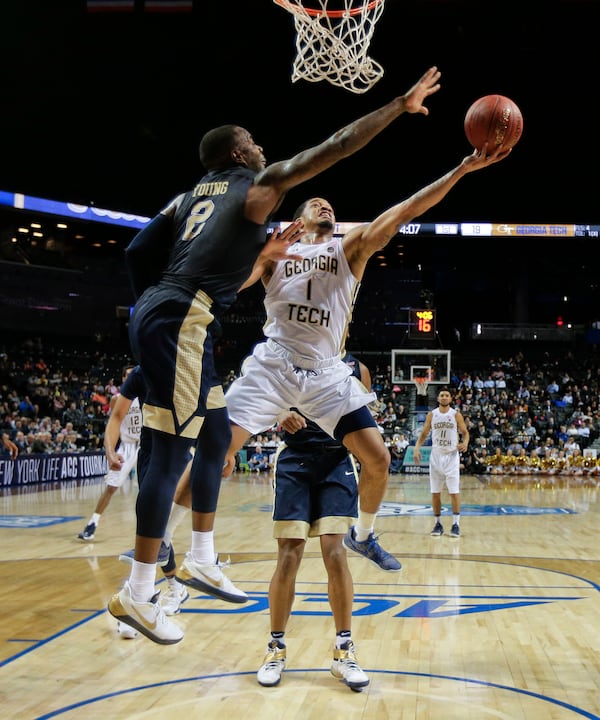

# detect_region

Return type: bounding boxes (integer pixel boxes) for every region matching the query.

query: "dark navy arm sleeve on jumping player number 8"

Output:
[125,213,173,300]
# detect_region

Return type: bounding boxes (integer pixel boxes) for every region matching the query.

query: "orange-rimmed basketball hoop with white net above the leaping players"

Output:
[273,0,385,94]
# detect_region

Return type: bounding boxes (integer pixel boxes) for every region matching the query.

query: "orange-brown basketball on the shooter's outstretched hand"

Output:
[465,95,523,153]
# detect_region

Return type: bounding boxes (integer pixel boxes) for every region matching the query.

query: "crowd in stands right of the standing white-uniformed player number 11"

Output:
[455,353,600,475]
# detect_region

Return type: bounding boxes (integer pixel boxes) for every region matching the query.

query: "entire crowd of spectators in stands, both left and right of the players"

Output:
[0,339,600,473]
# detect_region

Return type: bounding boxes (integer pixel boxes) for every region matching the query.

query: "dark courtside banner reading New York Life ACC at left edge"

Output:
[0,452,108,487]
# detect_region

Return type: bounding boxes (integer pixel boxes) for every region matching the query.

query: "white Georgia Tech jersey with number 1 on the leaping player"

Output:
[263,239,360,360]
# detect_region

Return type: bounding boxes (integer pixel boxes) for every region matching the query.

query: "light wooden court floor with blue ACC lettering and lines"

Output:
[0,475,600,720]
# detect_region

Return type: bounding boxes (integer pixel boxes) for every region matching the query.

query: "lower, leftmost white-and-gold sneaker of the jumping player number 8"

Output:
[108,582,183,645]
